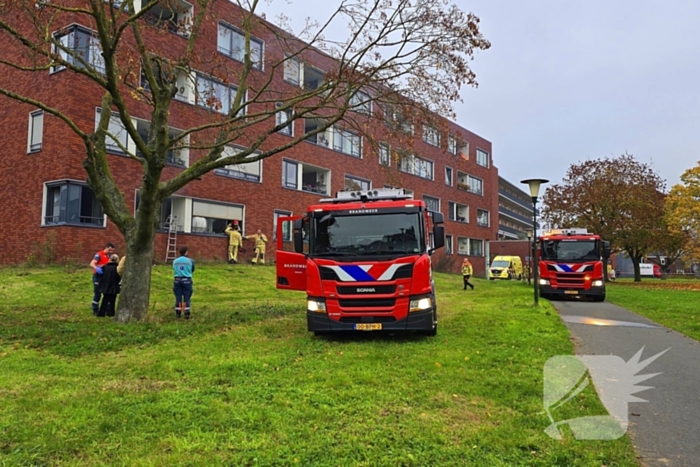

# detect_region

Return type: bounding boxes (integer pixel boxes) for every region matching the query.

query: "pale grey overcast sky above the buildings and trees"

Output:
[264,0,700,187]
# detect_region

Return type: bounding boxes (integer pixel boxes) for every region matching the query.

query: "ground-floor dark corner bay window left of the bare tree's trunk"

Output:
[44,181,105,227]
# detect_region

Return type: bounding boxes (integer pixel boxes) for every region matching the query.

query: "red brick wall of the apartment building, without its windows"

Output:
[0,2,498,275]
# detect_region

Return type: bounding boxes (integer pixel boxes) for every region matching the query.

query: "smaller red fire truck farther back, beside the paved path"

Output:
[539,229,610,302]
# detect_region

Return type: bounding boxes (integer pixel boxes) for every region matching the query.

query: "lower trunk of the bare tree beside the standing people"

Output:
[114,229,155,323]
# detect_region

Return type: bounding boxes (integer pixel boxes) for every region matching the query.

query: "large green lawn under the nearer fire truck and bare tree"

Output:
[0,264,638,467]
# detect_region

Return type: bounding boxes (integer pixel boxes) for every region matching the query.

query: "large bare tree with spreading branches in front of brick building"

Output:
[0,0,490,322]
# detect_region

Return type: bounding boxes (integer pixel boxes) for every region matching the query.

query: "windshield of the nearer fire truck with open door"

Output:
[310,213,425,257]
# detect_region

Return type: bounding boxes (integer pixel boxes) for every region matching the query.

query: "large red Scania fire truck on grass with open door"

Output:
[276,189,445,335]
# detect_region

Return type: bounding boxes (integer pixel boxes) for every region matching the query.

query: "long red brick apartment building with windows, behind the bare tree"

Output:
[0,2,499,274]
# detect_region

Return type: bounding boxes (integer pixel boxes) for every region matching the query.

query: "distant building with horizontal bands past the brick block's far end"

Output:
[498,176,532,240]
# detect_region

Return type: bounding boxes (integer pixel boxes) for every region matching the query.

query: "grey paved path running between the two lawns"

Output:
[552,301,700,467]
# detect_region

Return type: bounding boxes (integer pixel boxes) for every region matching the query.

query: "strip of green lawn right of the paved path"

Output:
[606,279,700,340]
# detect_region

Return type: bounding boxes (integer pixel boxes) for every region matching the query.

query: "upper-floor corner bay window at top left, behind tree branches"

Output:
[52,26,105,74]
